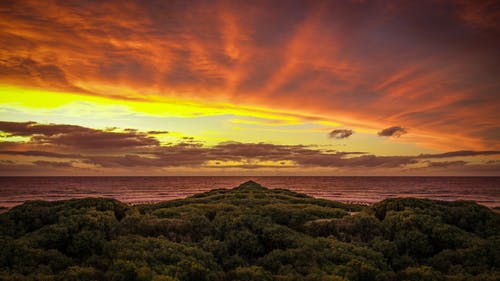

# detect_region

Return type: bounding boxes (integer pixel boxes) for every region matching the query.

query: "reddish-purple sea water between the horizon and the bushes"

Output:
[0,177,500,207]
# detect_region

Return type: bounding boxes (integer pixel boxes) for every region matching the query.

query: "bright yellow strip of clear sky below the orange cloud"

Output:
[0,85,444,155]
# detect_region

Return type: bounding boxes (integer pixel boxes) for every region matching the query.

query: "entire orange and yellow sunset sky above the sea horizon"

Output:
[0,0,500,176]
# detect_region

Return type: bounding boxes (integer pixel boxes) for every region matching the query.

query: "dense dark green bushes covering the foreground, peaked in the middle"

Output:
[0,182,500,281]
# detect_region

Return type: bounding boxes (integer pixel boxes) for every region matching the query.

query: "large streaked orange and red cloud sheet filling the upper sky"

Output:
[0,1,500,149]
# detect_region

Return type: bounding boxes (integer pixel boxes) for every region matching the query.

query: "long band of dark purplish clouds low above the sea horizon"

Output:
[0,122,500,171]
